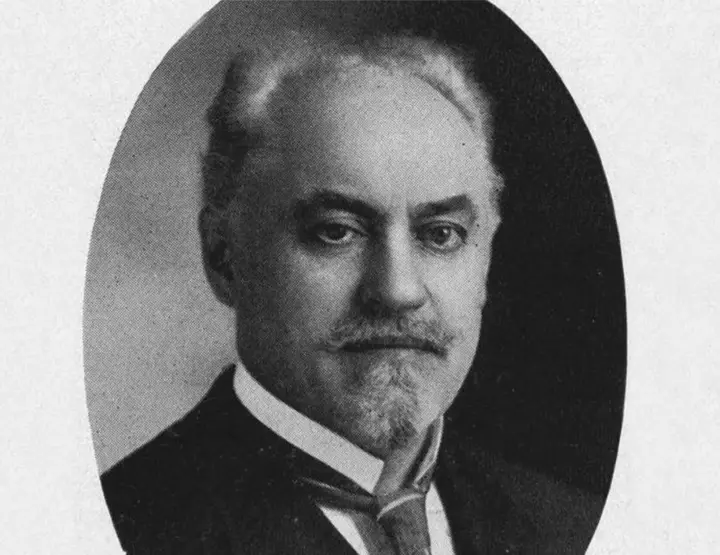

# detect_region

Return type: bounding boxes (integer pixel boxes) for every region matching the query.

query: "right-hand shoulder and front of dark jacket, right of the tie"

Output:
[443,437,604,555]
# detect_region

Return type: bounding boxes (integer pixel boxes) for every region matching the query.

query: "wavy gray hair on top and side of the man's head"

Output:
[203,33,502,211]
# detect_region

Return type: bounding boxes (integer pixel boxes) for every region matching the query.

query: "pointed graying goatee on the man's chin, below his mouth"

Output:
[339,358,430,456]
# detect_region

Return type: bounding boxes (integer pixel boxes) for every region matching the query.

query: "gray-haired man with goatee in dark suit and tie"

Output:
[103,31,599,555]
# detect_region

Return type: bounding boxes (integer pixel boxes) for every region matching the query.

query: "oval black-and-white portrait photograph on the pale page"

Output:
[84,1,626,554]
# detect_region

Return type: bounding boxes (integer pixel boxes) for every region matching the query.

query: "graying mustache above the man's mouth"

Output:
[325,317,455,356]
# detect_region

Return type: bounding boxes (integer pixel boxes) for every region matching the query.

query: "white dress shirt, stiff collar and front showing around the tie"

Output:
[233,363,454,555]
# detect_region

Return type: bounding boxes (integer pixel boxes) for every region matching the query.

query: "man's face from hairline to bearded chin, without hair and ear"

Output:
[222,70,497,456]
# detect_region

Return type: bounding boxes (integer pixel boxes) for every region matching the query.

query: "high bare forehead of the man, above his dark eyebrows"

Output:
[253,68,493,213]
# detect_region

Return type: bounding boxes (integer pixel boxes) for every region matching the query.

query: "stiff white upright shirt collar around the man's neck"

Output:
[233,362,443,493]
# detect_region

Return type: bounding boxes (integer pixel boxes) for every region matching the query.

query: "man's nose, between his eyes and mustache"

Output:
[361,232,428,312]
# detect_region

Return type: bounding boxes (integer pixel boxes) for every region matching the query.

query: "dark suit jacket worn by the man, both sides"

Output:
[102,369,602,555]
